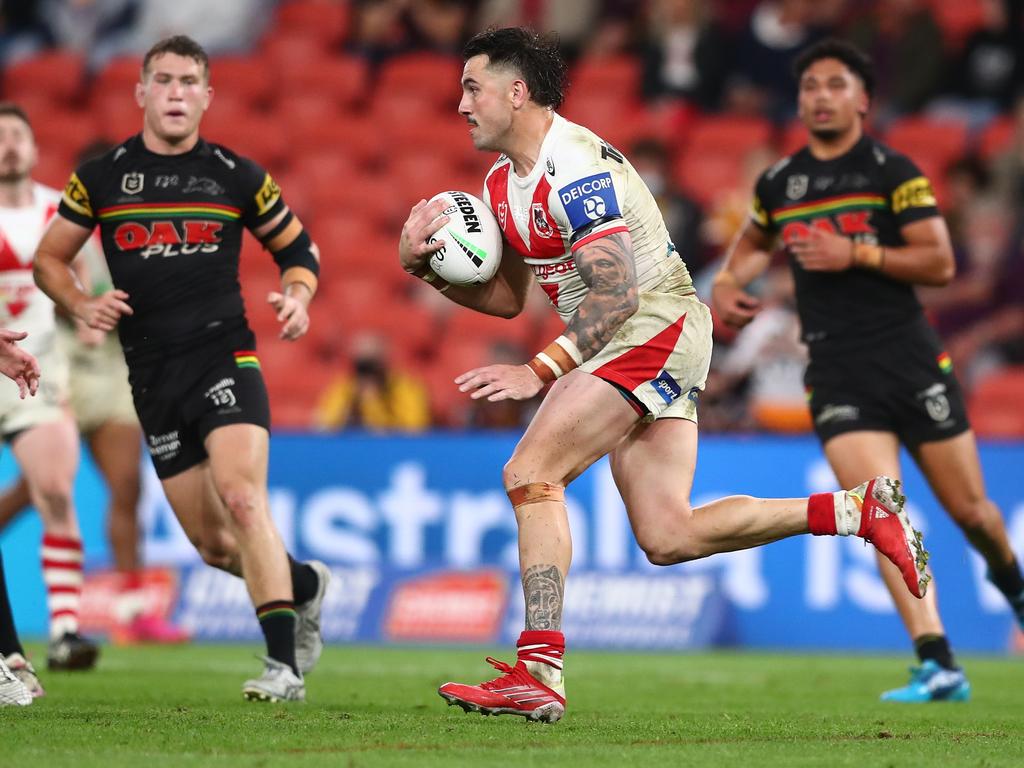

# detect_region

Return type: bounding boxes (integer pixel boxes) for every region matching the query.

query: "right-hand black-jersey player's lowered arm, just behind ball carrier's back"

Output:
[712,221,775,328]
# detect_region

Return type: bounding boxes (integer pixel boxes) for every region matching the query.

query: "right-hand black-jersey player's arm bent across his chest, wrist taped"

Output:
[788,216,955,286]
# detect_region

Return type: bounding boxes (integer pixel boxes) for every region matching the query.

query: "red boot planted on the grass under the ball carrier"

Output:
[437,656,565,723]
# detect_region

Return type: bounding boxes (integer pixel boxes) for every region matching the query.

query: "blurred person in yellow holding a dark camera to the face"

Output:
[314,332,430,432]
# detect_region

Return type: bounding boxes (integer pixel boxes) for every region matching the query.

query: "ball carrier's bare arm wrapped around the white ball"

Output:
[398,200,534,317]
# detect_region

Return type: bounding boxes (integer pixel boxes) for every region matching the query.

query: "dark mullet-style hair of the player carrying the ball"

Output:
[462,27,566,110]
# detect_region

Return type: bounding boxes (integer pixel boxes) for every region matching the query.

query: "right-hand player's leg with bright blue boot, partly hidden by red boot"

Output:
[824,430,971,701]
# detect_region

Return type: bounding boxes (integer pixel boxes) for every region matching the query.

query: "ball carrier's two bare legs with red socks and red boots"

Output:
[439,372,923,722]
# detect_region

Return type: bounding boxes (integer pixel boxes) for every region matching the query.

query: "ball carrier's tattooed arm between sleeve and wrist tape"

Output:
[565,232,638,360]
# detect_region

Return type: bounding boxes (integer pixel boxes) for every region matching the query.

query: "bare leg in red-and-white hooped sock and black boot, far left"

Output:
[11,418,99,670]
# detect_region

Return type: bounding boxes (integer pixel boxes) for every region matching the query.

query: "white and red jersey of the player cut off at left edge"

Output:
[0,184,60,357]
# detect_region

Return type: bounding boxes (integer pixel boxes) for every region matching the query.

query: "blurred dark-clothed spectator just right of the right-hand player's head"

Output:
[847,0,945,123]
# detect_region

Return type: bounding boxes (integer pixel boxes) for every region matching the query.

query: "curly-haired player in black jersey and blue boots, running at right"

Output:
[714,40,1024,701]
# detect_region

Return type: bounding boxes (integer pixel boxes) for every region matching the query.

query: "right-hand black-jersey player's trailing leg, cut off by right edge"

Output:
[914,432,1024,629]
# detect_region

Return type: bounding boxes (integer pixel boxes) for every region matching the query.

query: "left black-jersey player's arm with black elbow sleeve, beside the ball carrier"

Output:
[253,206,319,341]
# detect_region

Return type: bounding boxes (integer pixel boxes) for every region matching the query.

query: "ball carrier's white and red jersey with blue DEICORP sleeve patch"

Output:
[483,114,693,322]
